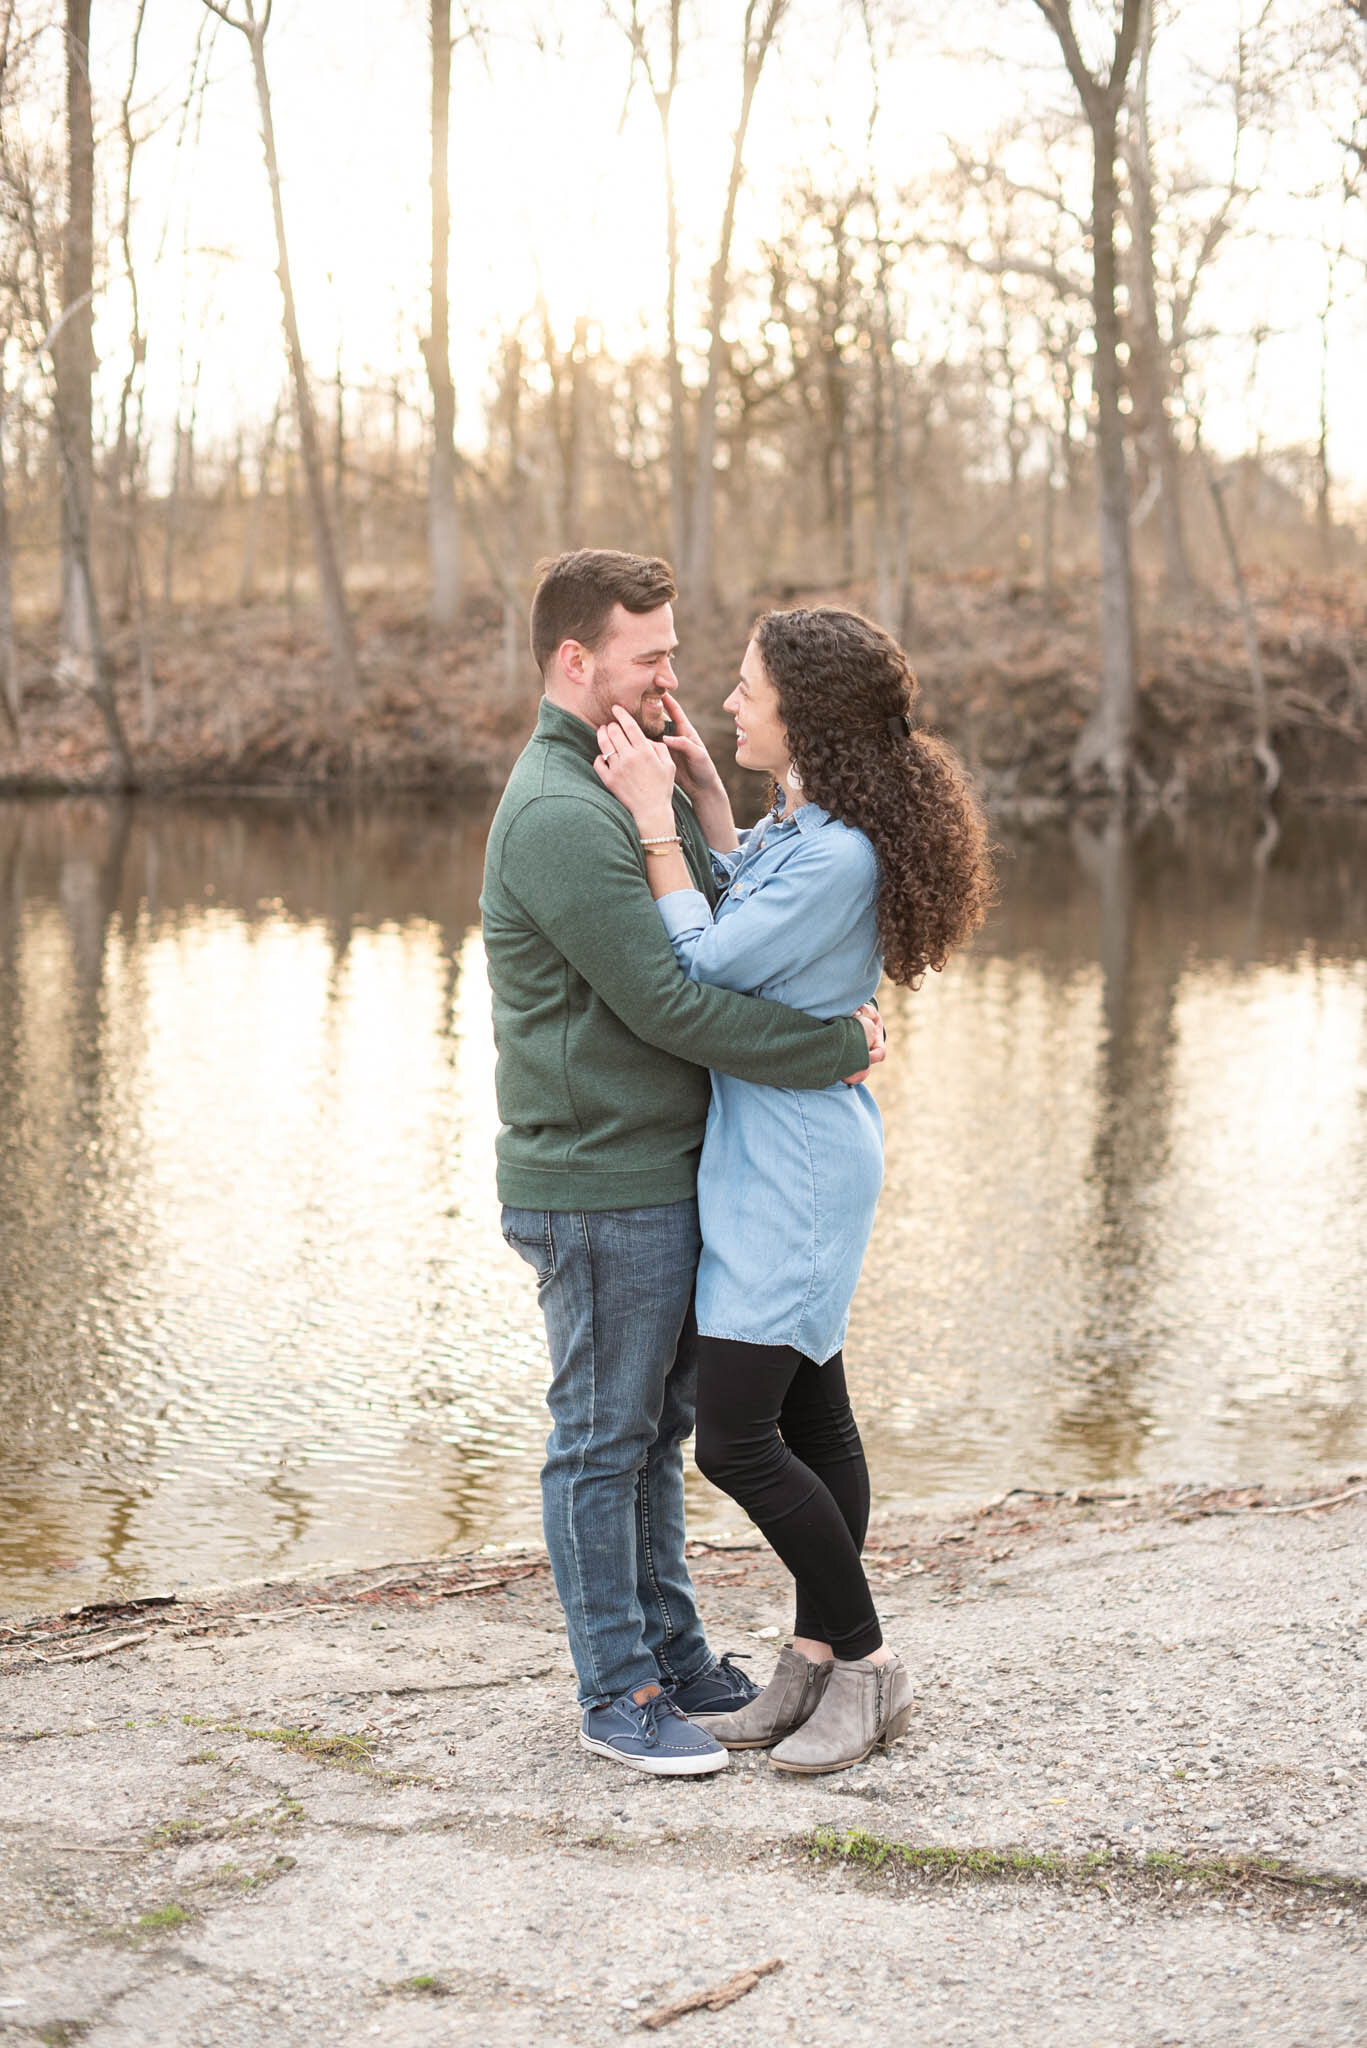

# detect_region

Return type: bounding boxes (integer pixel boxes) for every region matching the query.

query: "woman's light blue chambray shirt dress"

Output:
[658,803,883,1362]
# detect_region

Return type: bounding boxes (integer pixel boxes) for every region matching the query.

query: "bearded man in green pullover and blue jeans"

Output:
[480,549,881,1776]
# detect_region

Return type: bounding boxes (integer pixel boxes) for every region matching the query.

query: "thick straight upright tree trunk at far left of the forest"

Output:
[53,0,94,682]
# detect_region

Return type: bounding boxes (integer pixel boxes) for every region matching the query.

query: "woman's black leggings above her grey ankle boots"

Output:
[695,1337,883,1659]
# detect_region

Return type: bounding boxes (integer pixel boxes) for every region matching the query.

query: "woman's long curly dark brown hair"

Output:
[754,606,994,987]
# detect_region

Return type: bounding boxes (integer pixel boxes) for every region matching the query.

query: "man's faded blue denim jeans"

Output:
[502,1202,715,1706]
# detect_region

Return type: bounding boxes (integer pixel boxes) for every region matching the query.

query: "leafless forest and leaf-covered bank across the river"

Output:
[0,0,1367,801]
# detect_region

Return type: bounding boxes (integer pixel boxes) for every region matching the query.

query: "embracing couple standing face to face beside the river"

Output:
[482,549,990,1776]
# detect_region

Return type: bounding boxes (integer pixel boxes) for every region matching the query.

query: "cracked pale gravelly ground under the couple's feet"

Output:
[0,1475,1367,2048]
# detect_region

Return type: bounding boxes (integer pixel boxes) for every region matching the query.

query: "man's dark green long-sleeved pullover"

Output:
[480,698,867,1210]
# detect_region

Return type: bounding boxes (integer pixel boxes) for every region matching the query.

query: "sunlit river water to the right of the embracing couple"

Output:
[851,819,1367,1489]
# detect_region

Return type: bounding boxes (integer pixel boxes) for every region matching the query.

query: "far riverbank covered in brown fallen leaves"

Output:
[0,571,1367,805]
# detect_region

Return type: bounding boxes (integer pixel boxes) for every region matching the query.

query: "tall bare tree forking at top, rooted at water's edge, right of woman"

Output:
[1035,0,1142,795]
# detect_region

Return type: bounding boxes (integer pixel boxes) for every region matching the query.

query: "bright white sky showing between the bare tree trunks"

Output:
[43,0,1367,494]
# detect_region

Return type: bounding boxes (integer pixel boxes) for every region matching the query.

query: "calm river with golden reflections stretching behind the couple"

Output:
[0,799,1367,1608]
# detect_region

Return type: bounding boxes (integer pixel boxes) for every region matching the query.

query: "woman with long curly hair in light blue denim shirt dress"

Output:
[594,608,990,1774]
